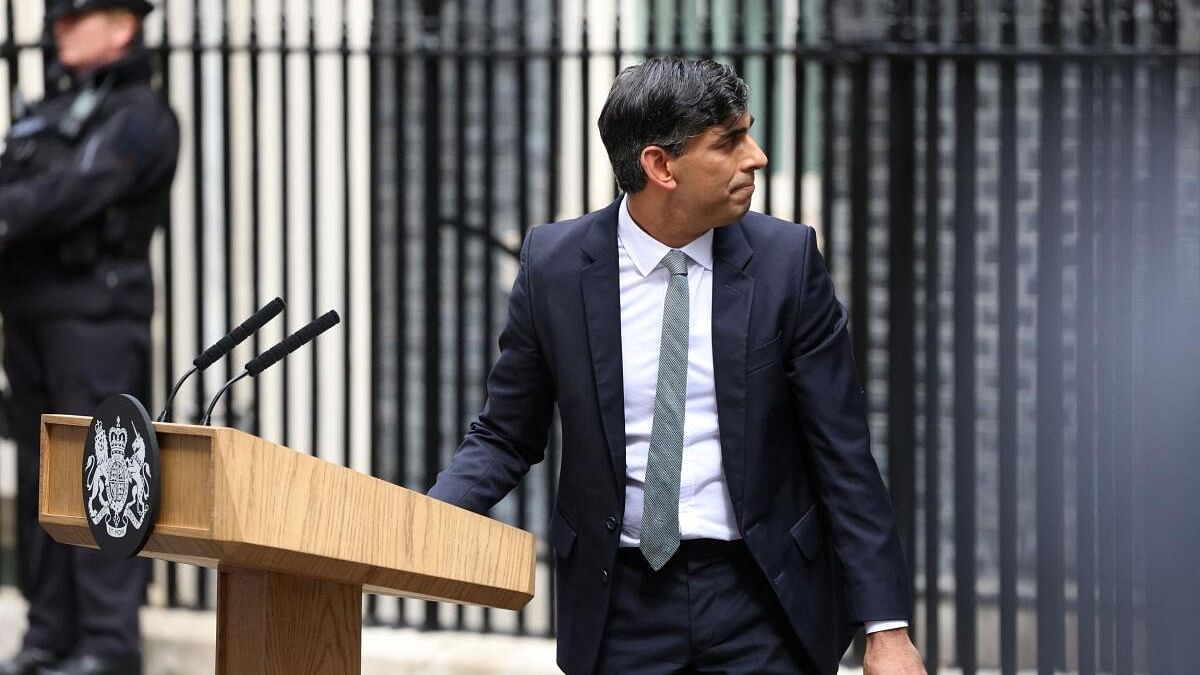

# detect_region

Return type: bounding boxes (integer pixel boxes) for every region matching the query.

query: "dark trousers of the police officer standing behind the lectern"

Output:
[4,316,150,661]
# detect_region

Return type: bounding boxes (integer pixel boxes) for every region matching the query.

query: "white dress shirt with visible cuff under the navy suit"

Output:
[617,192,908,633]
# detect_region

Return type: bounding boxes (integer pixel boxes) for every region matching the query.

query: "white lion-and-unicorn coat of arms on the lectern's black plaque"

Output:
[84,417,150,539]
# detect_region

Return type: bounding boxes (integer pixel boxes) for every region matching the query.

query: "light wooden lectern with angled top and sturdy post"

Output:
[38,414,536,675]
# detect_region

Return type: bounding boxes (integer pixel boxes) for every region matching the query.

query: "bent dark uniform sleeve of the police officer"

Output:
[0,100,179,241]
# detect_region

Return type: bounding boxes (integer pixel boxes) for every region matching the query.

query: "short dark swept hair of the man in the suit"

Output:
[600,56,750,193]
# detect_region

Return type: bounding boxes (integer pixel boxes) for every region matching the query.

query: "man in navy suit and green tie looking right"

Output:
[430,58,924,675]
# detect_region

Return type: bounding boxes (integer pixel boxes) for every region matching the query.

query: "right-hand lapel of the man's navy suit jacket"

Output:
[713,222,754,522]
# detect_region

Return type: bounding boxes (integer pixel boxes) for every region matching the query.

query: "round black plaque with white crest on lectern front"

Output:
[83,394,162,557]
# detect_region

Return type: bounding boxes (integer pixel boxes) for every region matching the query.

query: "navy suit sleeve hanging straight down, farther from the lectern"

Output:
[787,229,912,623]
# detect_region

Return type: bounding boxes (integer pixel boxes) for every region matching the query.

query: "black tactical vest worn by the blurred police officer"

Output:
[0,52,179,318]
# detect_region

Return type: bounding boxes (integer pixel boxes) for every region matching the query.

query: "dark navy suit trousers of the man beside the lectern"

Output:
[596,539,815,675]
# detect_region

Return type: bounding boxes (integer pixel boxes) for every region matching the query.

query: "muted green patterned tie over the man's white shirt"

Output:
[641,250,689,571]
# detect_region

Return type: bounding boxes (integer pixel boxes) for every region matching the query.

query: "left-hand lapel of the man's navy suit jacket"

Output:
[580,199,625,498]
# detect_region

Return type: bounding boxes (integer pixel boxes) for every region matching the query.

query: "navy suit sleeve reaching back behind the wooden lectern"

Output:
[428,229,554,513]
